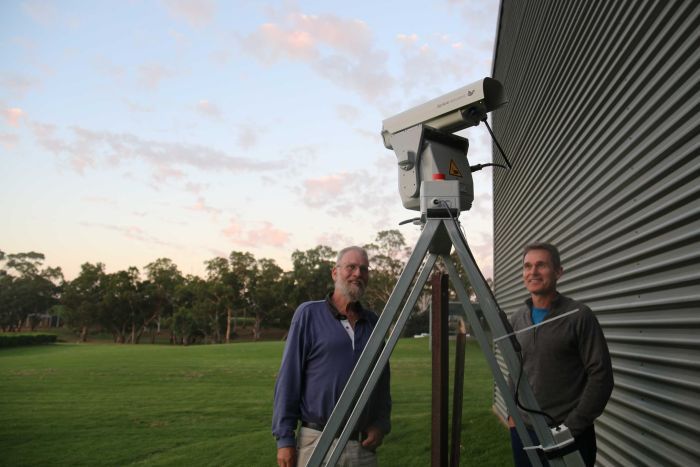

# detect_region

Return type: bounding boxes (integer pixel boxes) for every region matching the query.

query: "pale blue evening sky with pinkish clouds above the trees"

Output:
[0,0,499,280]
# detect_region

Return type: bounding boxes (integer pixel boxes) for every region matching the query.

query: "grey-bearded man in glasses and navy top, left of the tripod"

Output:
[272,246,391,467]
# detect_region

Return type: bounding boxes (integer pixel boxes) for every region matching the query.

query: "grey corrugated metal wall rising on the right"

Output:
[492,0,700,466]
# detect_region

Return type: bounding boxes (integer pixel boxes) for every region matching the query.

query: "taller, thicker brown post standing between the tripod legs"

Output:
[431,272,449,467]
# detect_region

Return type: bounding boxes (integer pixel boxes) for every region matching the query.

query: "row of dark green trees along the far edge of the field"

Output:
[0,230,440,344]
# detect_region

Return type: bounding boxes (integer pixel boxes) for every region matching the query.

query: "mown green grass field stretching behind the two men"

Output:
[0,339,511,467]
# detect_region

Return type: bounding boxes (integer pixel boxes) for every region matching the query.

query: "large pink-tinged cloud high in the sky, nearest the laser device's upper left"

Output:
[239,6,394,102]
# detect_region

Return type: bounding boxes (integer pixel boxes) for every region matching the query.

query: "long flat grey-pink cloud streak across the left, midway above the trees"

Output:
[30,119,290,180]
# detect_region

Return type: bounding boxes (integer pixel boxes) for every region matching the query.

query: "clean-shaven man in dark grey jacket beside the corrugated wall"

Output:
[509,243,613,466]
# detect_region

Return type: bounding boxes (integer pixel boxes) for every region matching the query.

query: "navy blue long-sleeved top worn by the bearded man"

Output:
[272,298,391,448]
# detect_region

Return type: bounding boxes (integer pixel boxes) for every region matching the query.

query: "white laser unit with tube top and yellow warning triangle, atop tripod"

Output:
[382,78,507,211]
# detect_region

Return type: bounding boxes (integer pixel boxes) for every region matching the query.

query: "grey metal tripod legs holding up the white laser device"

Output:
[307,214,583,467]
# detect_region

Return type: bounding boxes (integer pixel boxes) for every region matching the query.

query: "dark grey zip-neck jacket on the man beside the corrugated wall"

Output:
[510,294,613,436]
